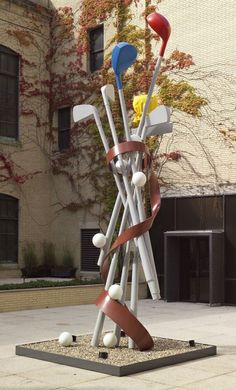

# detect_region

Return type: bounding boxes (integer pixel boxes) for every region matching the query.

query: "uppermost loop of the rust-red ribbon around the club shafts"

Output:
[106,141,150,163]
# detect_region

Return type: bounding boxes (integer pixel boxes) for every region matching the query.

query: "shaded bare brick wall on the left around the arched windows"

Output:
[0,0,101,277]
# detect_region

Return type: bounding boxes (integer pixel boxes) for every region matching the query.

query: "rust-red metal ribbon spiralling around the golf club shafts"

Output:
[96,141,161,351]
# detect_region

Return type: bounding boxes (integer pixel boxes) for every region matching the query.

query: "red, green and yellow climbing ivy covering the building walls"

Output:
[1,0,206,218]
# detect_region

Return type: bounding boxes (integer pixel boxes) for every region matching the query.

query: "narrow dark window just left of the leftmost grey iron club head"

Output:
[58,107,71,151]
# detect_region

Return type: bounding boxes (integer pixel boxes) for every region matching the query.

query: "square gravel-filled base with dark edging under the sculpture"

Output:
[16,335,216,376]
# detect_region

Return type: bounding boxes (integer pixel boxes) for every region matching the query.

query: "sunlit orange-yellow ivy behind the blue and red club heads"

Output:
[74,0,206,216]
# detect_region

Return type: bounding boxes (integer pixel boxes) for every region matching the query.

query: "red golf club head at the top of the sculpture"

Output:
[147,12,171,57]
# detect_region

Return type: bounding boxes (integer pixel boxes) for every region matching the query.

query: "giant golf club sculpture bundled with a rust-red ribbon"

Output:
[73,12,172,351]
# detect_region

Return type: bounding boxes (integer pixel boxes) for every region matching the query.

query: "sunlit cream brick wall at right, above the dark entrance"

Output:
[155,0,236,196]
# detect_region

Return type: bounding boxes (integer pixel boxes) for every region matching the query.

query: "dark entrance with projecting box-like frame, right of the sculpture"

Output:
[164,230,224,305]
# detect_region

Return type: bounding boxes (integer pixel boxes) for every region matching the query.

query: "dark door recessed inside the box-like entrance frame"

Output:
[179,237,209,303]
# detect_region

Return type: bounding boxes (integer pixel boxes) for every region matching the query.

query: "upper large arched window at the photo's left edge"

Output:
[0,45,19,138]
